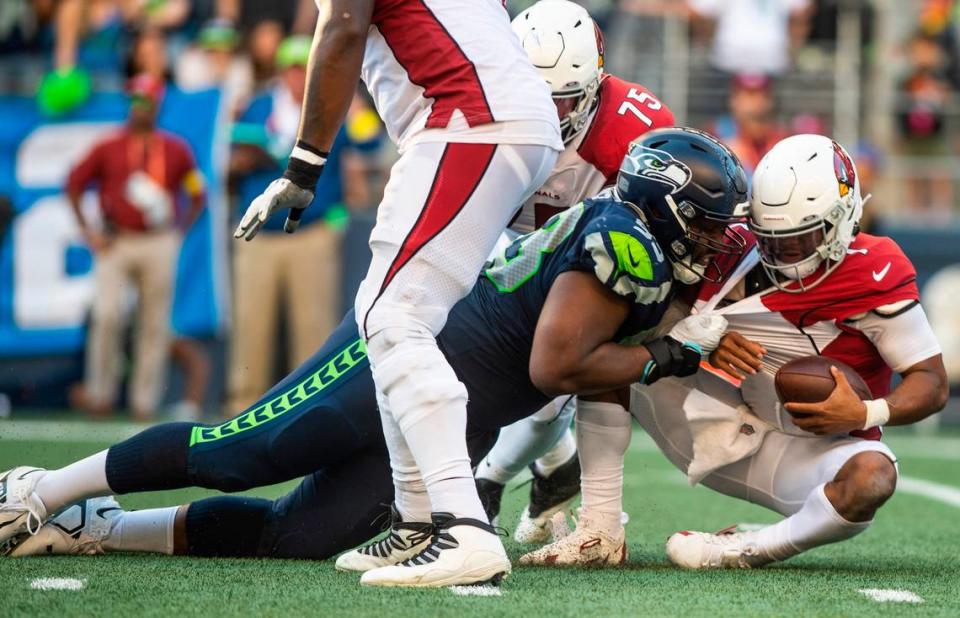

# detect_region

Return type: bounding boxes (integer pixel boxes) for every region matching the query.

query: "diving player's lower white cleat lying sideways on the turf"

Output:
[10,496,123,558]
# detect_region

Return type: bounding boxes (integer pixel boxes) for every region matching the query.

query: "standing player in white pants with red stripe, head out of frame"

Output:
[234,0,563,586]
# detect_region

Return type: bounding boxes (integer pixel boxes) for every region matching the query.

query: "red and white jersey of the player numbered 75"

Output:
[510,75,674,233]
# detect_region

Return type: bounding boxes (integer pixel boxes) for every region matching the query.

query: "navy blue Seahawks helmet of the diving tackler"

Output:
[616,127,749,283]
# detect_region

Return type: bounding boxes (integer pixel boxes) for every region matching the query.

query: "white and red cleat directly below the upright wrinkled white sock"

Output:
[520,510,627,568]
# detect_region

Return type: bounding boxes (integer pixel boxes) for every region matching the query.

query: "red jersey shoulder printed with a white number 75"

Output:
[577,74,674,181]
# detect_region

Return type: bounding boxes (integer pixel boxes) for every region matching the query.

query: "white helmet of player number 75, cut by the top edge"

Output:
[513,0,603,144]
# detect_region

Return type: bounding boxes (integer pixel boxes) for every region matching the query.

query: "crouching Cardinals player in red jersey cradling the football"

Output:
[521,135,948,569]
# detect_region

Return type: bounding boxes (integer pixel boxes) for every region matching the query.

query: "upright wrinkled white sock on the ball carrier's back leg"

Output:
[577,400,632,536]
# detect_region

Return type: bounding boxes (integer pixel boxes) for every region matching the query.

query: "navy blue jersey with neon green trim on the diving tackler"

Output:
[438,197,673,428]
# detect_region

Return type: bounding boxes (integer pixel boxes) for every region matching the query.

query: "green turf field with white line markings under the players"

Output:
[0,421,960,618]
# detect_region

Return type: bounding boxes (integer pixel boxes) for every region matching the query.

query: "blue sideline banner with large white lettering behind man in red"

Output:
[0,88,226,358]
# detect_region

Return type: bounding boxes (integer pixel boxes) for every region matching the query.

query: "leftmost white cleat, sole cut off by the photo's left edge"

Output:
[0,466,47,556]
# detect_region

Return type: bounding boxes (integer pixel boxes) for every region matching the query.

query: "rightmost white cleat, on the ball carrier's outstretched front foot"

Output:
[667,528,771,569]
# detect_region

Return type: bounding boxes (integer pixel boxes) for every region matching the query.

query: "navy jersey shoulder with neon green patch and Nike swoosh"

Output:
[578,198,673,304]
